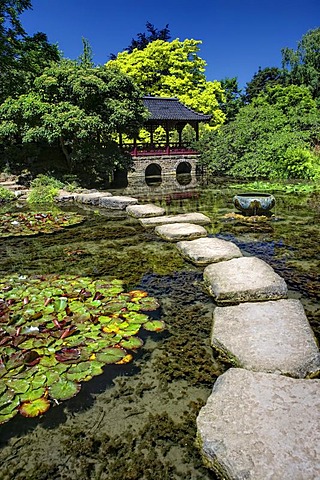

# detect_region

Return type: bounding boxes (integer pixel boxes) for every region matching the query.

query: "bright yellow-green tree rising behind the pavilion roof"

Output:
[107,39,225,127]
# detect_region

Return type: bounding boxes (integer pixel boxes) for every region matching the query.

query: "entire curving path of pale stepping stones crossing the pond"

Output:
[55,195,320,480]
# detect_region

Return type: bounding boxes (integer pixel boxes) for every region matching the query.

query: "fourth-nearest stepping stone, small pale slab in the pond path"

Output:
[177,237,242,265]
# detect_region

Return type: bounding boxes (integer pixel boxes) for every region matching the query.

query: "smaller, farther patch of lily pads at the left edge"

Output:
[0,212,84,237]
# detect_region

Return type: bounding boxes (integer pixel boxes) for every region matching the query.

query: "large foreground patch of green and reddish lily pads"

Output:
[0,275,164,424]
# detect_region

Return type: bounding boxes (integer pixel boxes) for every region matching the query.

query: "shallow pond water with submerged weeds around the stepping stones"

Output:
[0,179,320,480]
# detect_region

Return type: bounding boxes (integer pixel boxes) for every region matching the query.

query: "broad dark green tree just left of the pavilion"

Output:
[0,60,145,179]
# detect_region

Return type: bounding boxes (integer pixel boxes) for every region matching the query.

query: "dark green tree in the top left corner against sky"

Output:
[0,0,60,103]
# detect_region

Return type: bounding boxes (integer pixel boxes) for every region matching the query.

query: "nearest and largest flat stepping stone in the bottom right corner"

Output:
[197,368,320,480]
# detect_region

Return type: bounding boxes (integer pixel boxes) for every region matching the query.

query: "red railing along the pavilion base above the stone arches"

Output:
[122,142,198,157]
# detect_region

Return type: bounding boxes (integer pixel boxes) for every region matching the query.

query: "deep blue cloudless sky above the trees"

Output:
[22,0,320,87]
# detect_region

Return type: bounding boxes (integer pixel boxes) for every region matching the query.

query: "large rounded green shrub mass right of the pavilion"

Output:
[198,85,320,179]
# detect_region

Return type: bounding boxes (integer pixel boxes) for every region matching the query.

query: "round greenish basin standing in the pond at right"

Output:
[233,193,276,215]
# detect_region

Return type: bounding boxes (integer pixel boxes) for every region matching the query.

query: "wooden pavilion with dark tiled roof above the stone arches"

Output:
[120,96,211,157]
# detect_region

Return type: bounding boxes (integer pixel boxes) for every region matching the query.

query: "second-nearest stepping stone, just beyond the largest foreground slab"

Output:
[211,300,320,378]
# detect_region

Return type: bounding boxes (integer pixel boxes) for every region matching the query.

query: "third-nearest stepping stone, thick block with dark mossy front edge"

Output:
[203,257,287,304]
